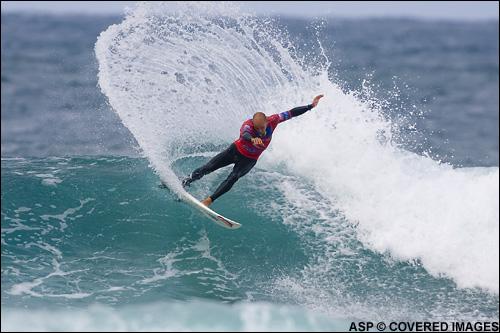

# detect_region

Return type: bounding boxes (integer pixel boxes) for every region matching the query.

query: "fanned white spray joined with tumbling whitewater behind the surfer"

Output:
[95,3,499,294]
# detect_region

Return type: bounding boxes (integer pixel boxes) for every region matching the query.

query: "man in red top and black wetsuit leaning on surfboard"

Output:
[182,95,323,207]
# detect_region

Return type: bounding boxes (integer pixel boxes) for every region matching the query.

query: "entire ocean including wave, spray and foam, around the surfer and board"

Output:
[1,3,499,331]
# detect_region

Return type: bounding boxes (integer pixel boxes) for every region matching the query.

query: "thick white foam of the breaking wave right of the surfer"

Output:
[266,75,499,293]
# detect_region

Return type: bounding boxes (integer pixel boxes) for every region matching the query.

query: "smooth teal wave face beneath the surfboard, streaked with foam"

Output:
[1,156,498,320]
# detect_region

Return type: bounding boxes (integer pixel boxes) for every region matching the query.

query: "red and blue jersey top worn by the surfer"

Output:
[234,104,312,160]
